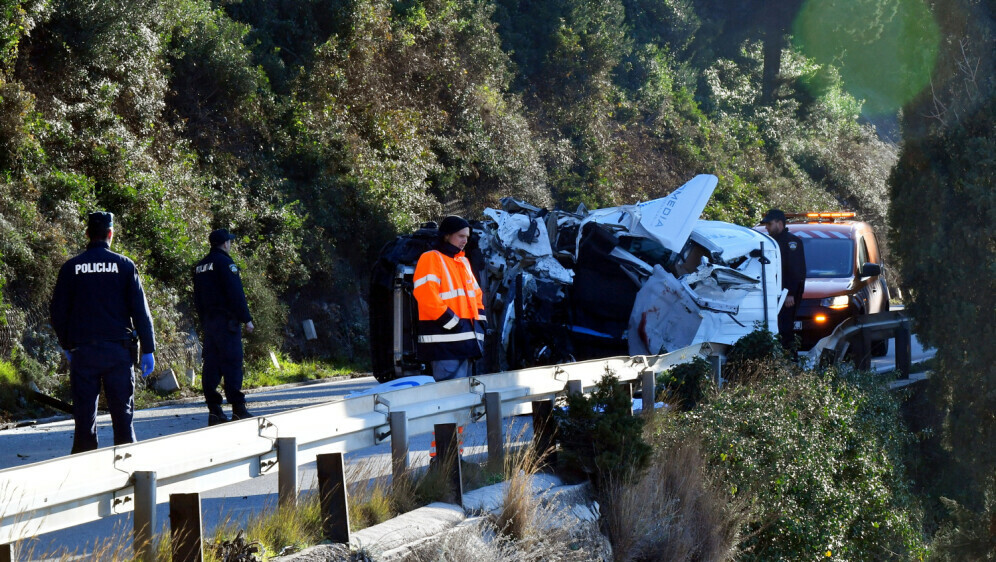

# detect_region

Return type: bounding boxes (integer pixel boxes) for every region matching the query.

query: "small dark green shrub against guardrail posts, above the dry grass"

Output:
[554,372,650,486]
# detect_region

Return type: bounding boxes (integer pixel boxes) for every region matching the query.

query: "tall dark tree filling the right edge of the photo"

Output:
[889,1,996,560]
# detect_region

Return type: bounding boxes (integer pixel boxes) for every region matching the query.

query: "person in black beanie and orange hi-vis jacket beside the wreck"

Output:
[414,215,487,381]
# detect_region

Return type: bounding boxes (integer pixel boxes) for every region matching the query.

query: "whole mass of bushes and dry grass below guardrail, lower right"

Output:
[557,330,927,560]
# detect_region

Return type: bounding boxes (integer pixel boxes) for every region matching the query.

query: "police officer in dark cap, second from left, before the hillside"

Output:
[194,229,255,425]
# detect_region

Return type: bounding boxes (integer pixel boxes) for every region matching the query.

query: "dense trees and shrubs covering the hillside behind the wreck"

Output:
[0,0,895,380]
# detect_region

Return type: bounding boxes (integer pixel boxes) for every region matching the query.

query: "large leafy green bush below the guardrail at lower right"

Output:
[654,366,925,560]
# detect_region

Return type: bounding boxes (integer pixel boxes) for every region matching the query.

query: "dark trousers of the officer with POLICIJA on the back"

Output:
[69,342,135,453]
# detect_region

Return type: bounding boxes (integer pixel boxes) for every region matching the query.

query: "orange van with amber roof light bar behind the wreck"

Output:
[755,212,889,357]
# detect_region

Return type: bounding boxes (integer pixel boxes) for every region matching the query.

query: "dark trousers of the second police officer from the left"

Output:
[201,321,246,407]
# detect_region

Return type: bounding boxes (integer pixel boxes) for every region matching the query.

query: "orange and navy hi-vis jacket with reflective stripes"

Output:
[414,250,485,361]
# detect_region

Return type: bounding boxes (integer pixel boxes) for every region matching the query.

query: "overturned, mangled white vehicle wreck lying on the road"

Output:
[370,175,786,380]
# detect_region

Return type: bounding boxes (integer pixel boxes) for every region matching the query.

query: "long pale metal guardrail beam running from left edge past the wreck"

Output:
[0,343,716,545]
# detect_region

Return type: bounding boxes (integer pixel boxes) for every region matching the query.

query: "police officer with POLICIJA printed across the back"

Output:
[49,212,156,453]
